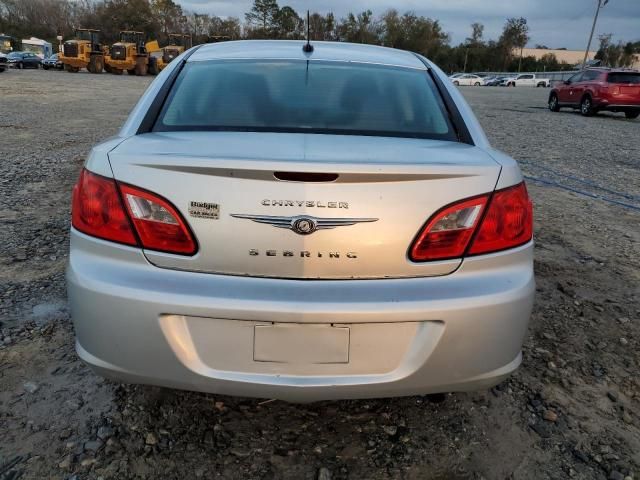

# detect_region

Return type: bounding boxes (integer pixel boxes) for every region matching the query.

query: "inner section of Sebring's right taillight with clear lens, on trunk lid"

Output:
[410,195,489,262]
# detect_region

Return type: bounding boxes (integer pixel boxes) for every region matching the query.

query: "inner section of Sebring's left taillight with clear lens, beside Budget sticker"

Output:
[120,184,198,255]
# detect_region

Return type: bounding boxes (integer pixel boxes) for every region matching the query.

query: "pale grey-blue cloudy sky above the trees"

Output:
[176,0,640,50]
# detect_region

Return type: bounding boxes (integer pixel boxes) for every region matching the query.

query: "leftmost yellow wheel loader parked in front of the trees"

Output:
[58,28,105,73]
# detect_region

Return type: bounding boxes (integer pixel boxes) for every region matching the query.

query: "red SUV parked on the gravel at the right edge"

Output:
[549,68,640,118]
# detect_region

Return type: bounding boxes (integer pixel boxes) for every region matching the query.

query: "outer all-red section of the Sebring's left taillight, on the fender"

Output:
[71,170,138,245]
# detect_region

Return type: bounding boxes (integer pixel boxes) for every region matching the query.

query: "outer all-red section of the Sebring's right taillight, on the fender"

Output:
[469,182,533,255]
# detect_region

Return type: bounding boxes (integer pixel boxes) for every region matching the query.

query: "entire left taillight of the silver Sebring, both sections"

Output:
[72,170,197,255]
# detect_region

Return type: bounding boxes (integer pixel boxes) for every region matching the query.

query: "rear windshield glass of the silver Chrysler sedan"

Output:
[154,60,457,140]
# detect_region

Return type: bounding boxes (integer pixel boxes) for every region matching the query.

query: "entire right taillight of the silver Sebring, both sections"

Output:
[409,182,533,262]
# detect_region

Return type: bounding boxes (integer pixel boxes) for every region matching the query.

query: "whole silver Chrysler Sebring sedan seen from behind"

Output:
[67,41,534,401]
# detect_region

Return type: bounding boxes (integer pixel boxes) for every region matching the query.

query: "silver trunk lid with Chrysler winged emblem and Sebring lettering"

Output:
[109,132,500,279]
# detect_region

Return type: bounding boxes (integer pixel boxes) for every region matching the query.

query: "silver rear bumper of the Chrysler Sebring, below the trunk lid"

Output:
[67,231,535,401]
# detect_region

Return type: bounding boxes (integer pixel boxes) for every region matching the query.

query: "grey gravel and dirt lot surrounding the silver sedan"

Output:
[0,71,640,480]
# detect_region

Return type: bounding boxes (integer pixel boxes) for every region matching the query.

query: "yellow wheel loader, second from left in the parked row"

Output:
[105,30,160,76]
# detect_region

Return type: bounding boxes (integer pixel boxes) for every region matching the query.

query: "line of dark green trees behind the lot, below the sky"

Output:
[0,0,640,72]
